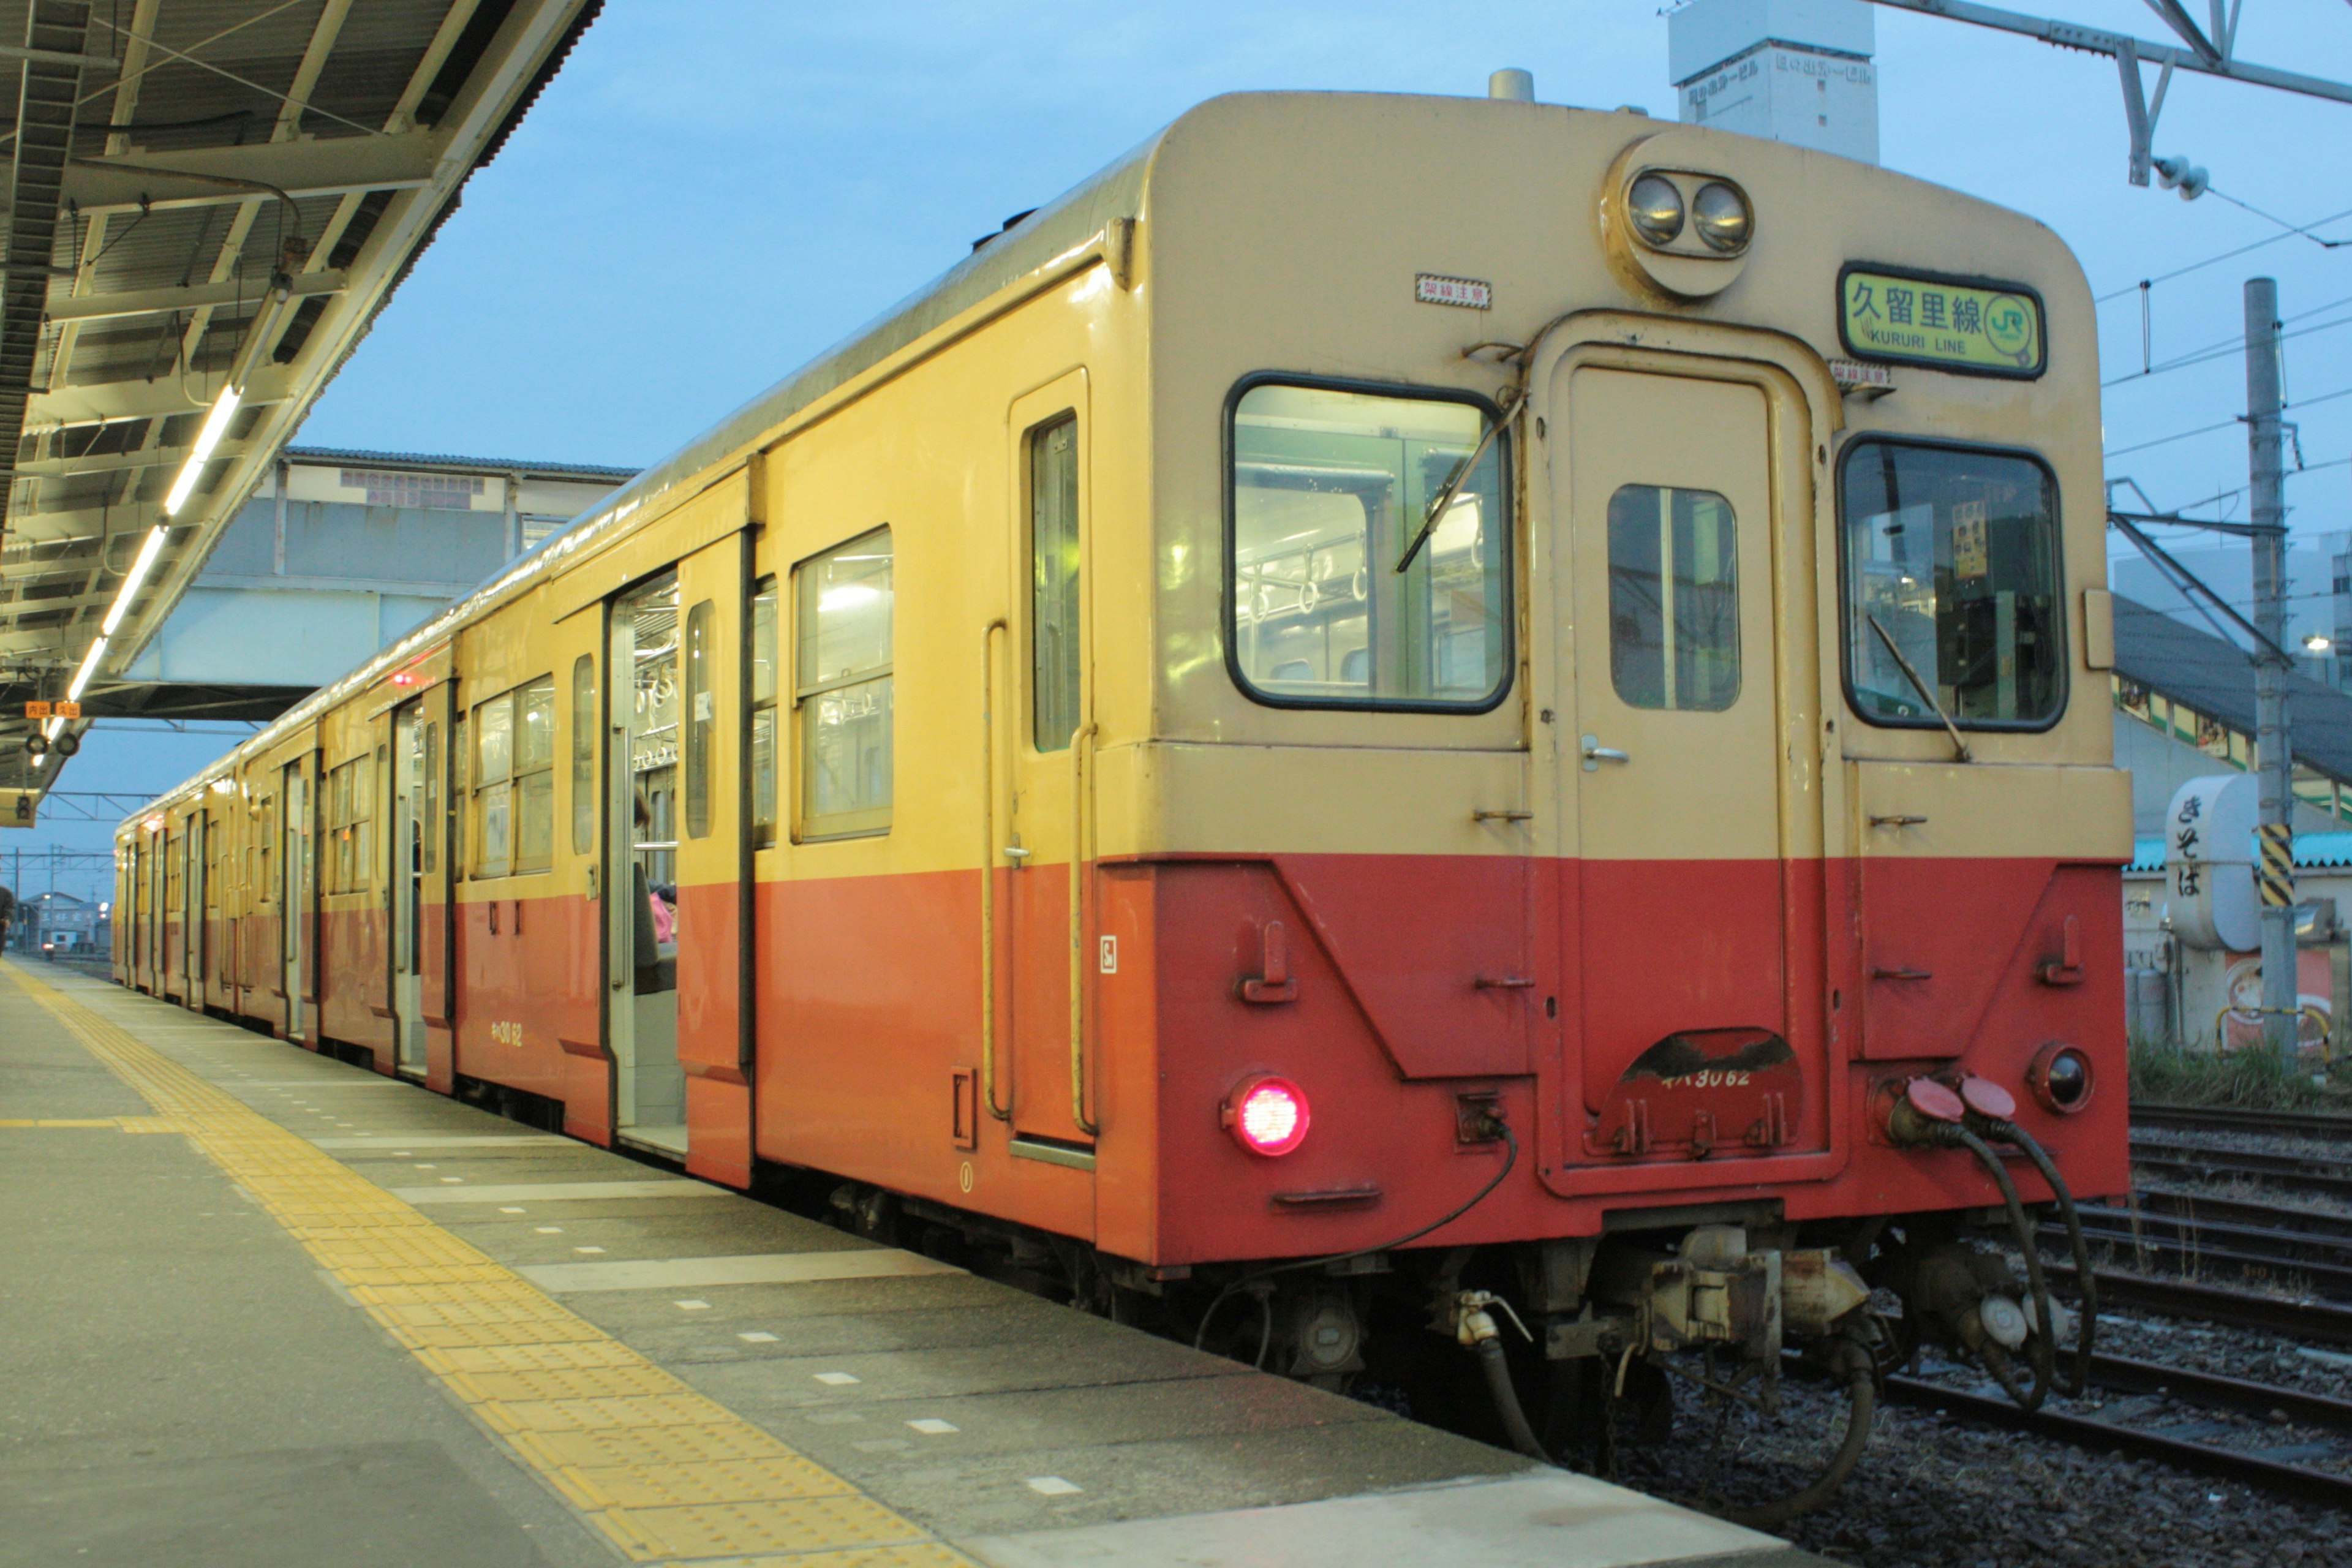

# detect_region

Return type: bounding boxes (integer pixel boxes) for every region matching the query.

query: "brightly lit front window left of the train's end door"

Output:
[1227,383,1512,712]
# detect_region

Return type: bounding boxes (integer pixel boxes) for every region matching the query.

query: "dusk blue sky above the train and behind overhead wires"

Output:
[0,0,2352,907]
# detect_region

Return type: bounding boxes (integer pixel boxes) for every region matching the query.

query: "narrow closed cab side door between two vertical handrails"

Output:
[997,399,1112,1170]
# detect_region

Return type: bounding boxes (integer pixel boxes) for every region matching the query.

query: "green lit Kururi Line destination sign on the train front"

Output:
[1837,266,2049,379]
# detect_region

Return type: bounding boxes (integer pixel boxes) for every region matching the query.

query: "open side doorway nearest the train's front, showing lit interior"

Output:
[602,571,687,1159]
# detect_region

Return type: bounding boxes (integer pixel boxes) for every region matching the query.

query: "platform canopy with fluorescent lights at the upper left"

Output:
[0,0,600,788]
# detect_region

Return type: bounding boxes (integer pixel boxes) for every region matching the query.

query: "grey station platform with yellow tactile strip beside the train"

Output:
[0,964,1820,1568]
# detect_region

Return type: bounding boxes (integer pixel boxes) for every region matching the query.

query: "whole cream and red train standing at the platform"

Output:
[113,92,2131,1518]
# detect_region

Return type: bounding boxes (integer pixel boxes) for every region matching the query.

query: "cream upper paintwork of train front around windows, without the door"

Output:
[1140,94,2112,853]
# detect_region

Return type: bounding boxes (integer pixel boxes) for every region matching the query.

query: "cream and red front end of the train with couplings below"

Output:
[1110,96,2131,1495]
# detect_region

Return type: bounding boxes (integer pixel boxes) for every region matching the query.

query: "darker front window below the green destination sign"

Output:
[1839,440,2067,729]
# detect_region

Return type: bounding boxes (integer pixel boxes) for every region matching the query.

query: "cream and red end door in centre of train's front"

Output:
[1550,350,1828,1180]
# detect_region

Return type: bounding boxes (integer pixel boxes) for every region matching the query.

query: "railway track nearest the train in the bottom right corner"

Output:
[1887,1354,2352,1507]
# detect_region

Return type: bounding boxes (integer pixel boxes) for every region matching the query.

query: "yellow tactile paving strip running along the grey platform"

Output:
[0,968,971,1568]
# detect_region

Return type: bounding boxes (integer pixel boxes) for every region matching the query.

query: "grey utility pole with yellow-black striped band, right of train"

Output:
[2246,277,2301,1055]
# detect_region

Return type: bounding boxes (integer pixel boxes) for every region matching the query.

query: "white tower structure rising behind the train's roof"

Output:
[1665,0,1879,162]
